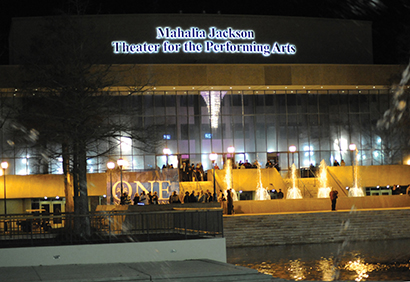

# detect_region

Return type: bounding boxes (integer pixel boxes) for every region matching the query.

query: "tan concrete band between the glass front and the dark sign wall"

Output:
[0,64,404,91]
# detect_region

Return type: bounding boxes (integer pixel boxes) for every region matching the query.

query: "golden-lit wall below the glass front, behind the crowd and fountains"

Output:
[0,165,410,205]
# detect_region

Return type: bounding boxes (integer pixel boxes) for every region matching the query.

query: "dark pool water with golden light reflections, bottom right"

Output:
[227,240,410,281]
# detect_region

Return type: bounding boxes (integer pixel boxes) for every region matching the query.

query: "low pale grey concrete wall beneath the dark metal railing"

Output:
[0,238,226,267]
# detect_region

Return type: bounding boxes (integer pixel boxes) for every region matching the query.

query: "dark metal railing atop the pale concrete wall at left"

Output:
[0,209,223,248]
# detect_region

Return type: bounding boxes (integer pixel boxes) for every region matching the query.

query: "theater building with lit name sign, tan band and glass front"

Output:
[1,14,409,212]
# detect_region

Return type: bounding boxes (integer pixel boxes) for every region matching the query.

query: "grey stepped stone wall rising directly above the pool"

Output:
[224,208,410,247]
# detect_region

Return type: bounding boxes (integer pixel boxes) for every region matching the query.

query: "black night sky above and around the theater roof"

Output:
[0,0,410,64]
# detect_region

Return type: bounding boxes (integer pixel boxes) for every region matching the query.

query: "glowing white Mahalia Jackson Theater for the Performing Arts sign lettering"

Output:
[111,27,296,57]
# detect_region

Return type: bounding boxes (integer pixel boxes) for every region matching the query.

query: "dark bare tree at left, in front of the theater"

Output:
[11,15,159,236]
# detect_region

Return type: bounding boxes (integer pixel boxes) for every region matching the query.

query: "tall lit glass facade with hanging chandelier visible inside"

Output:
[2,89,405,175]
